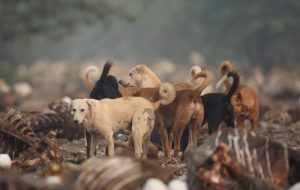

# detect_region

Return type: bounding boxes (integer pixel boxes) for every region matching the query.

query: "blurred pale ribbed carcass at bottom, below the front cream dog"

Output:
[75,157,172,190]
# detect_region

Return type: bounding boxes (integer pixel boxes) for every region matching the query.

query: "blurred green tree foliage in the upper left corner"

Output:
[0,0,138,43]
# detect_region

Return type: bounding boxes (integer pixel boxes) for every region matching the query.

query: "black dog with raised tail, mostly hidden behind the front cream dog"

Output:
[85,61,121,157]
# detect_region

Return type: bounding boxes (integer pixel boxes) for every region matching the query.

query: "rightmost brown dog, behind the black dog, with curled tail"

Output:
[220,61,259,132]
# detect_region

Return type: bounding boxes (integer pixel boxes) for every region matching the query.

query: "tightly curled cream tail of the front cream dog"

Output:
[154,83,176,109]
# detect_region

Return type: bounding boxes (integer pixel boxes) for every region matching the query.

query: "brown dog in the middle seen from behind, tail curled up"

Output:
[134,71,213,157]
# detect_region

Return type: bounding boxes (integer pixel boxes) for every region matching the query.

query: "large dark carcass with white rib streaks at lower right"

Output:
[188,128,290,187]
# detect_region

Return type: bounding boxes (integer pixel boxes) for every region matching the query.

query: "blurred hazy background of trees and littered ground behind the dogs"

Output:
[0,0,300,141]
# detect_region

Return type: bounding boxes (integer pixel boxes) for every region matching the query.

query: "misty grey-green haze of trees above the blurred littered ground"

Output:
[0,0,300,81]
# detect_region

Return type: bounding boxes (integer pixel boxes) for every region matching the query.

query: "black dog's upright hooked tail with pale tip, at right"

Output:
[216,71,240,100]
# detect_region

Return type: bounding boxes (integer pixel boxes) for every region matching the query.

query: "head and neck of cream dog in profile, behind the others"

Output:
[119,65,161,88]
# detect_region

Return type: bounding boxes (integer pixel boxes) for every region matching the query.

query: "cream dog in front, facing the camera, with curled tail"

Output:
[71,83,176,158]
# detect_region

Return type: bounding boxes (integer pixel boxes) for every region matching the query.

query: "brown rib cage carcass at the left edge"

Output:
[0,109,61,172]
